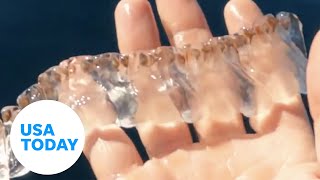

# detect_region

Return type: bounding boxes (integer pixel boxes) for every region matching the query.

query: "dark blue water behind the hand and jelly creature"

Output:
[0,0,320,179]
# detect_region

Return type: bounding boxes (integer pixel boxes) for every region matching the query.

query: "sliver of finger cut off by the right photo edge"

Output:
[307,32,320,159]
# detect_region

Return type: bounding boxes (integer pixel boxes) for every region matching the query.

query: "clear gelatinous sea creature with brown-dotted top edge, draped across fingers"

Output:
[0,12,307,177]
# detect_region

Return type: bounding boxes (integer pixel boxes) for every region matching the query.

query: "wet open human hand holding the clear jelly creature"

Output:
[85,0,320,180]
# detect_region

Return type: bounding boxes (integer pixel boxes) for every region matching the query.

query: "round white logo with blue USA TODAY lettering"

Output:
[10,100,85,175]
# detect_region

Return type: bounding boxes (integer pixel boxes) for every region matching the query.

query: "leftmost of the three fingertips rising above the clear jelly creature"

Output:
[115,0,160,53]
